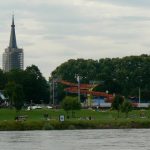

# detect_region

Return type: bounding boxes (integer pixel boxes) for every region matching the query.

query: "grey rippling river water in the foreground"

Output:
[0,129,150,150]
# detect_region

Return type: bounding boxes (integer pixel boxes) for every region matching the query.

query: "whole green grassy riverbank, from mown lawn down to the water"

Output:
[0,109,150,131]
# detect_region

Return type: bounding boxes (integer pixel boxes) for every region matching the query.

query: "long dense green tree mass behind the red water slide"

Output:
[52,55,150,101]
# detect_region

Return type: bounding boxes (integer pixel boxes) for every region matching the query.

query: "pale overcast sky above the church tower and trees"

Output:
[0,0,150,79]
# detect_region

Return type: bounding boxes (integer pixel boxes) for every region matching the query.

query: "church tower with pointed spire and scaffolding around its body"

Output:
[3,16,24,72]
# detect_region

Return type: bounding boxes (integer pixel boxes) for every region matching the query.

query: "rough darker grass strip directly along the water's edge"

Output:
[0,119,150,131]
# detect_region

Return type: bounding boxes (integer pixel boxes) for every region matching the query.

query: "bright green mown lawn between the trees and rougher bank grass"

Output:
[0,109,150,121]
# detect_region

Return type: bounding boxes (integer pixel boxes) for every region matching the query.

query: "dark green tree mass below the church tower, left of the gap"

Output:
[0,65,49,104]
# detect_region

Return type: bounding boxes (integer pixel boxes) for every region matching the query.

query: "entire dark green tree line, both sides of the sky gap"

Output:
[0,54,150,107]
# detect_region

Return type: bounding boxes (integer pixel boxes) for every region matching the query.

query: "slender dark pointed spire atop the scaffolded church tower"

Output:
[9,15,17,48]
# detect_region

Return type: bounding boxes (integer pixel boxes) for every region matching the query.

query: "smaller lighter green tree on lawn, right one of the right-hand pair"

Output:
[121,100,133,118]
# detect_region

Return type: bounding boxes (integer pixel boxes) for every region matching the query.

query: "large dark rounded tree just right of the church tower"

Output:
[23,65,49,104]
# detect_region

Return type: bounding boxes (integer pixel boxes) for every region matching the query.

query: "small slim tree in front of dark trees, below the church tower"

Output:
[12,84,24,111]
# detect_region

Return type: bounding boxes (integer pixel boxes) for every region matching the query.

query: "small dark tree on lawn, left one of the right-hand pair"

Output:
[111,95,124,118]
